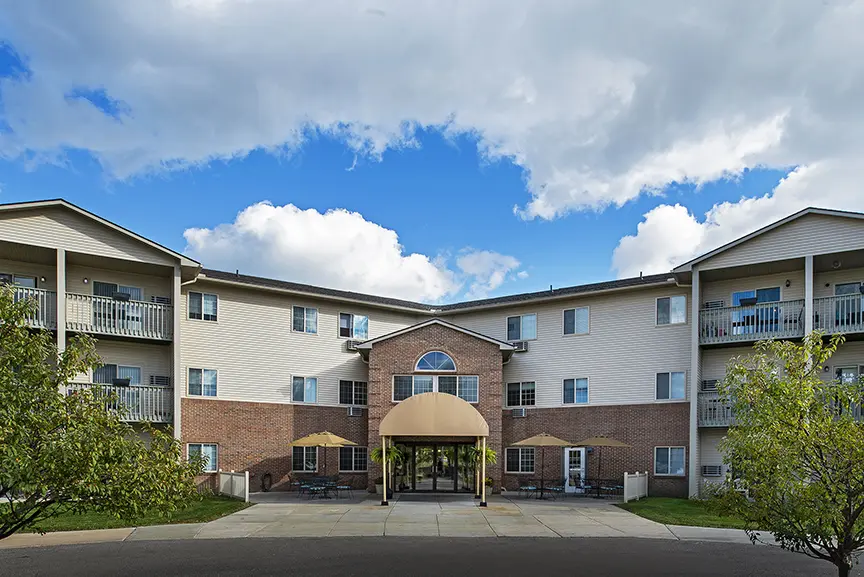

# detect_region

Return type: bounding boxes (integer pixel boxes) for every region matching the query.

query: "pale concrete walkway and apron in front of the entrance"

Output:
[0,496,749,548]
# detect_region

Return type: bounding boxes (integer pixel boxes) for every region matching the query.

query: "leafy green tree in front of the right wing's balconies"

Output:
[714,333,864,576]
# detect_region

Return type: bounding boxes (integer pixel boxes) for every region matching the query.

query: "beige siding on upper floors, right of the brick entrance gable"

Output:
[447,287,691,410]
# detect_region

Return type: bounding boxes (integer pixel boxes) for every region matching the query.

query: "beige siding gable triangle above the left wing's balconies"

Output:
[0,207,175,265]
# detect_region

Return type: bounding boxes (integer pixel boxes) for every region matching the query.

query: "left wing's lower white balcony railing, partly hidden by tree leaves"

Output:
[66,383,174,423]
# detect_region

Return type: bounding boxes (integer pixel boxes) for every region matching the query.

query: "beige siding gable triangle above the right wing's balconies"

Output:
[698,214,864,270]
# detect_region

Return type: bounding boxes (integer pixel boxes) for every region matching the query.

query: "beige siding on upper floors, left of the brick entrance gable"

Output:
[179,281,420,405]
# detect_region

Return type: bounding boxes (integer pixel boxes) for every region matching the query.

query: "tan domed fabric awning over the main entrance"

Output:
[378,393,489,437]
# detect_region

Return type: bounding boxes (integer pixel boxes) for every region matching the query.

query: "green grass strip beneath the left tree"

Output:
[12,496,251,533]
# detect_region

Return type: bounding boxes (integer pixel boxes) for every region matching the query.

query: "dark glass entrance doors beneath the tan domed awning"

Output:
[396,443,474,493]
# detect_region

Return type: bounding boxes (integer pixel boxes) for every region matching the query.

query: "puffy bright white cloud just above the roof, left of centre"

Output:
[184,202,519,301]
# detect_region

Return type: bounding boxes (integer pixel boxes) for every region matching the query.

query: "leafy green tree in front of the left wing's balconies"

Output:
[0,286,202,539]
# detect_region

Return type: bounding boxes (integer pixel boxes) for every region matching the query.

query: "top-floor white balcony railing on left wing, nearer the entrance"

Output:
[66,293,173,340]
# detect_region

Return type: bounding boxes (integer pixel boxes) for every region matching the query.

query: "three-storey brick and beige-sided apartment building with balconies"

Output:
[6,200,864,496]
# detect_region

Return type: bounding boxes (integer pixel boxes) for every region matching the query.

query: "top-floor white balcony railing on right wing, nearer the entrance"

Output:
[699,299,804,344]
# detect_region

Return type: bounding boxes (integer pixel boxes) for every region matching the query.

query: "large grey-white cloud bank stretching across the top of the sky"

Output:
[0,0,864,220]
